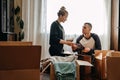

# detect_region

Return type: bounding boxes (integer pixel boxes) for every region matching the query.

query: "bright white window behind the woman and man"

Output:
[47,0,106,35]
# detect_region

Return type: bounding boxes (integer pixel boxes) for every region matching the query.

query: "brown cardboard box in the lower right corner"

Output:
[107,51,120,80]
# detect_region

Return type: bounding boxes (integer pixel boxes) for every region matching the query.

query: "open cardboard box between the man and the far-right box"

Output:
[95,50,114,79]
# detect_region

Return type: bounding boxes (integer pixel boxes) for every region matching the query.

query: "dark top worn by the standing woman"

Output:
[49,21,65,56]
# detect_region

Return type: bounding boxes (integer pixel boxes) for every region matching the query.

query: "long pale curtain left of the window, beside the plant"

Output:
[22,0,49,59]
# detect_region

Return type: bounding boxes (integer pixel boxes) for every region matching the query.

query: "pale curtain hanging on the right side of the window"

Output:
[100,0,111,50]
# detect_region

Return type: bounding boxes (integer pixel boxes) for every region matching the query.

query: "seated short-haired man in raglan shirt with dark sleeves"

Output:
[72,23,101,79]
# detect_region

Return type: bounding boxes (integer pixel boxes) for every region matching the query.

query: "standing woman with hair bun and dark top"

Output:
[49,7,72,56]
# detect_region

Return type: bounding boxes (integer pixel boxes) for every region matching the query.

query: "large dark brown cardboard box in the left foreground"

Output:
[0,46,41,80]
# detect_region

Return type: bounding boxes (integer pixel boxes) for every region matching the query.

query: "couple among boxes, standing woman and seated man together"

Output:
[49,7,101,56]
